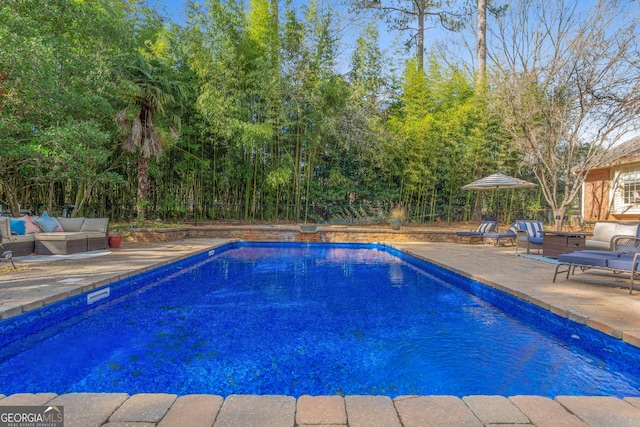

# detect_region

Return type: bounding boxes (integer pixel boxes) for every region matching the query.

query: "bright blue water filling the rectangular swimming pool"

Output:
[0,243,640,397]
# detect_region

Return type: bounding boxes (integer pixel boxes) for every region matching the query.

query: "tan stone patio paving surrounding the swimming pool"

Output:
[0,238,640,427]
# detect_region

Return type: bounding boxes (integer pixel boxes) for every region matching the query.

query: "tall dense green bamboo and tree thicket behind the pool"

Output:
[0,0,544,226]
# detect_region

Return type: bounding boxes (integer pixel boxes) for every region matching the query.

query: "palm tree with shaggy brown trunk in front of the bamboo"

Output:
[116,54,184,221]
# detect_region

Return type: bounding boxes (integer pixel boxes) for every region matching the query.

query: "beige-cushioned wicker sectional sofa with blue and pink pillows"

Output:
[0,213,109,256]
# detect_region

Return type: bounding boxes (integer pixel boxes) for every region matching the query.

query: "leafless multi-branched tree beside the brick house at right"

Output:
[492,0,640,229]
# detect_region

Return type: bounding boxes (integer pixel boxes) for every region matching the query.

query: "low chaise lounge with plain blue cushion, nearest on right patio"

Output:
[553,236,640,294]
